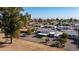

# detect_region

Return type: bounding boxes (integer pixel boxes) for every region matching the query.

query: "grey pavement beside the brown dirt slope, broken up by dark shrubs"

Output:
[21,34,79,51]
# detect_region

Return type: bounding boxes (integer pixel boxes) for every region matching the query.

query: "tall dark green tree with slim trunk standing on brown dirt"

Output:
[0,7,23,43]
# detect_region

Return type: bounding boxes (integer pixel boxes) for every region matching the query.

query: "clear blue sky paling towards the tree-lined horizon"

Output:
[24,7,79,19]
